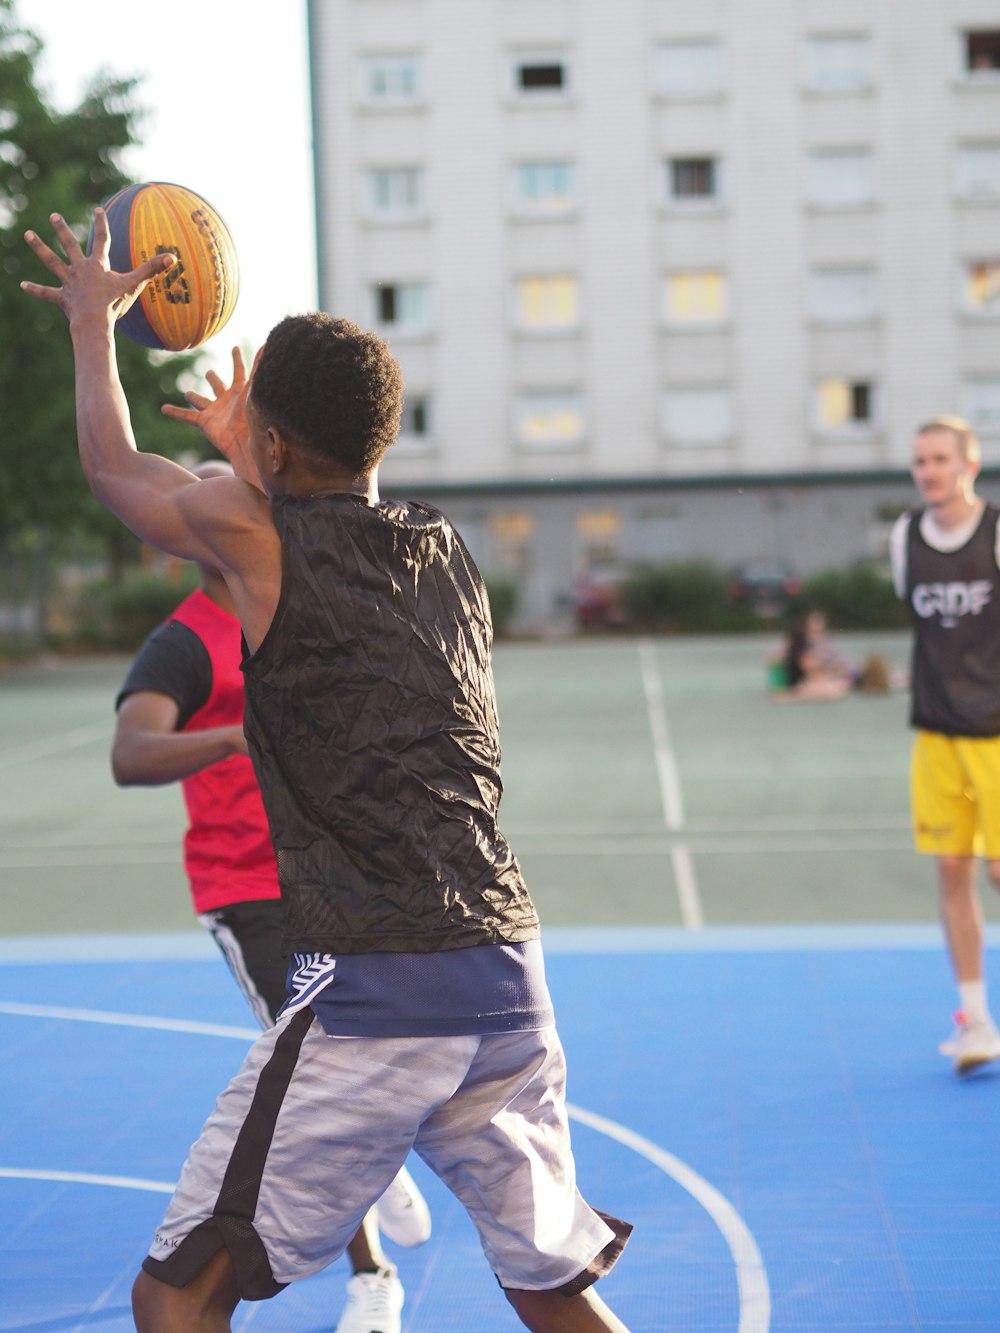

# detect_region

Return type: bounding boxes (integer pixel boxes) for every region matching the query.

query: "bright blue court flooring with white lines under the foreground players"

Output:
[0,925,1000,1333]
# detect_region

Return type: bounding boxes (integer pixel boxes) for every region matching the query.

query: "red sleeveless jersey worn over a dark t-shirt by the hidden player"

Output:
[169,591,281,912]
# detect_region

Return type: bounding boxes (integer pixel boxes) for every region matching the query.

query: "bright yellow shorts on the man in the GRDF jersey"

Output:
[909,732,1000,861]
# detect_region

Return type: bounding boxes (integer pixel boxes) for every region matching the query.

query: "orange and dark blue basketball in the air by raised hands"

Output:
[91,181,240,352]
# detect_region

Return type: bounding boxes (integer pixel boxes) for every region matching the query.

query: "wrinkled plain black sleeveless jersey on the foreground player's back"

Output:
[243,493,539,953]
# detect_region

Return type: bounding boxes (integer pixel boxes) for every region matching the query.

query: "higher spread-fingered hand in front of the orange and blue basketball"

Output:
[21,208,177,327]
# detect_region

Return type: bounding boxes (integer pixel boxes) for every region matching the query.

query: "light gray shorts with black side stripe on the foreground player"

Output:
[143,1009,632,1301]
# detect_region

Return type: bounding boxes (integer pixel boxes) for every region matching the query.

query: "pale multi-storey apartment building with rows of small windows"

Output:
[309,0,1000,621]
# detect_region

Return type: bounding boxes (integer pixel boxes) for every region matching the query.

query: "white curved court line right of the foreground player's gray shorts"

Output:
[567,1102,771,1333]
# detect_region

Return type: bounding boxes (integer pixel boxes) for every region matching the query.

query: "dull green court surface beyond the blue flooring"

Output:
[0,633,996,936]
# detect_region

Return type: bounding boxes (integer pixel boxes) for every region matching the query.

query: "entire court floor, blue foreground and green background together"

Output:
[0,636,1000,1333]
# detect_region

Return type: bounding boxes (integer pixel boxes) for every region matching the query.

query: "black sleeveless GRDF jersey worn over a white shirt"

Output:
[907,504,1000,736]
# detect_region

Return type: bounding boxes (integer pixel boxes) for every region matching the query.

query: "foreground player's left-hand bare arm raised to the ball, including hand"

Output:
[21,209,271,568]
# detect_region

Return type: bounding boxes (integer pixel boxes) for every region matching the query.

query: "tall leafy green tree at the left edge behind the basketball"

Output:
[0,0,193,549]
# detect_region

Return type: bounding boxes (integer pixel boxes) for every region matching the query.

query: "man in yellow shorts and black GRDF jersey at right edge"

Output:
[892,417,1000,1073]
